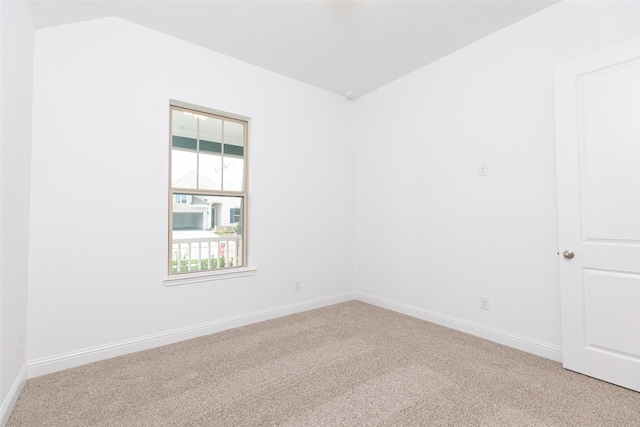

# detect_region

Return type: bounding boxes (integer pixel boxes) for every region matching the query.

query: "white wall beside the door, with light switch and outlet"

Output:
[355,2,640,358]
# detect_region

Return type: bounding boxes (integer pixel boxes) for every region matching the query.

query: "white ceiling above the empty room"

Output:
[28,0,558,97]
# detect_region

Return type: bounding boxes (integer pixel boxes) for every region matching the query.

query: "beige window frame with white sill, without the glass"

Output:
[164,100,256,286]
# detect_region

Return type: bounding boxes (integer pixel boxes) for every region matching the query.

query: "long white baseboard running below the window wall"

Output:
[28,292,354,378]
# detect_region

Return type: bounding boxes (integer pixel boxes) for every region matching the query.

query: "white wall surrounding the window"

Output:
[28,18,353,375]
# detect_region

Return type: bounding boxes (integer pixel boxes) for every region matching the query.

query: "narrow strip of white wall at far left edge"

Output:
[0,1,35,424]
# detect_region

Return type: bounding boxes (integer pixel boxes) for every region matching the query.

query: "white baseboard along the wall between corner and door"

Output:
[355,292,562,362]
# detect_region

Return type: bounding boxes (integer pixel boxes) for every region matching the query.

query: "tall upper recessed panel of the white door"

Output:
[577,60,640,243]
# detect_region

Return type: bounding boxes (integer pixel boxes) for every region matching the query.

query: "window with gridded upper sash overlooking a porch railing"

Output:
[168,103,247,276]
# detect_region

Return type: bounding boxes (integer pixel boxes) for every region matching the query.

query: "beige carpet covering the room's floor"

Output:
[8,301,640,427]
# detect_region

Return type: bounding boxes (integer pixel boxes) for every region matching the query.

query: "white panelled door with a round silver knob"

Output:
[555,39,640,391]
